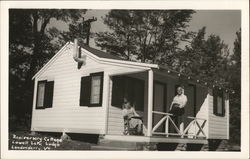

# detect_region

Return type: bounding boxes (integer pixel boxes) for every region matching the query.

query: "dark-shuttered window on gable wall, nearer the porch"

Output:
[80,72,103,106]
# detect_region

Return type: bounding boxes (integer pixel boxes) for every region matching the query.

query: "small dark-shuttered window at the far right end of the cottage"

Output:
[213,90,225,116]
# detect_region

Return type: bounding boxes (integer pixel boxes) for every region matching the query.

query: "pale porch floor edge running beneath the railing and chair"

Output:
[104,135,208,144]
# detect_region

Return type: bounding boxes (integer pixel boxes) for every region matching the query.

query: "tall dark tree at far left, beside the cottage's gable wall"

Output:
[9,9,86,130]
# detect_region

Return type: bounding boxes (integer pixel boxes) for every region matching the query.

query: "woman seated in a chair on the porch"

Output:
[123,101,142,135]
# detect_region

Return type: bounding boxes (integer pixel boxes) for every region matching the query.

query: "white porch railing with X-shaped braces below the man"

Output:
[152,111,206,138]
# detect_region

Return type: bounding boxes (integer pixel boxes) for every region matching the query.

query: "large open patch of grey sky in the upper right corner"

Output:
[188,10,241,50]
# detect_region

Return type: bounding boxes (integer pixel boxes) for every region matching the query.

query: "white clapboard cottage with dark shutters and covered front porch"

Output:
[31,39,229,150]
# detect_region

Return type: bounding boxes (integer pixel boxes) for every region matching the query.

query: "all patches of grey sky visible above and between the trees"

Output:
[50,10,241,53]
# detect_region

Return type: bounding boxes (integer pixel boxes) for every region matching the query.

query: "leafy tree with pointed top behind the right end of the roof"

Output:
[179,27,229,86]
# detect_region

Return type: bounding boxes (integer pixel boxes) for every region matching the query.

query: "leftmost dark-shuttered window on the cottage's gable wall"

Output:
[36,80,54,109]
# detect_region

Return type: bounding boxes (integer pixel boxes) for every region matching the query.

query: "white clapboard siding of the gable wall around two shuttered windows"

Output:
[31,44,145,133]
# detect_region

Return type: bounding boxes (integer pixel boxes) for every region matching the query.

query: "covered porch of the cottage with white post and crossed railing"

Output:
[105,69,207,144]
